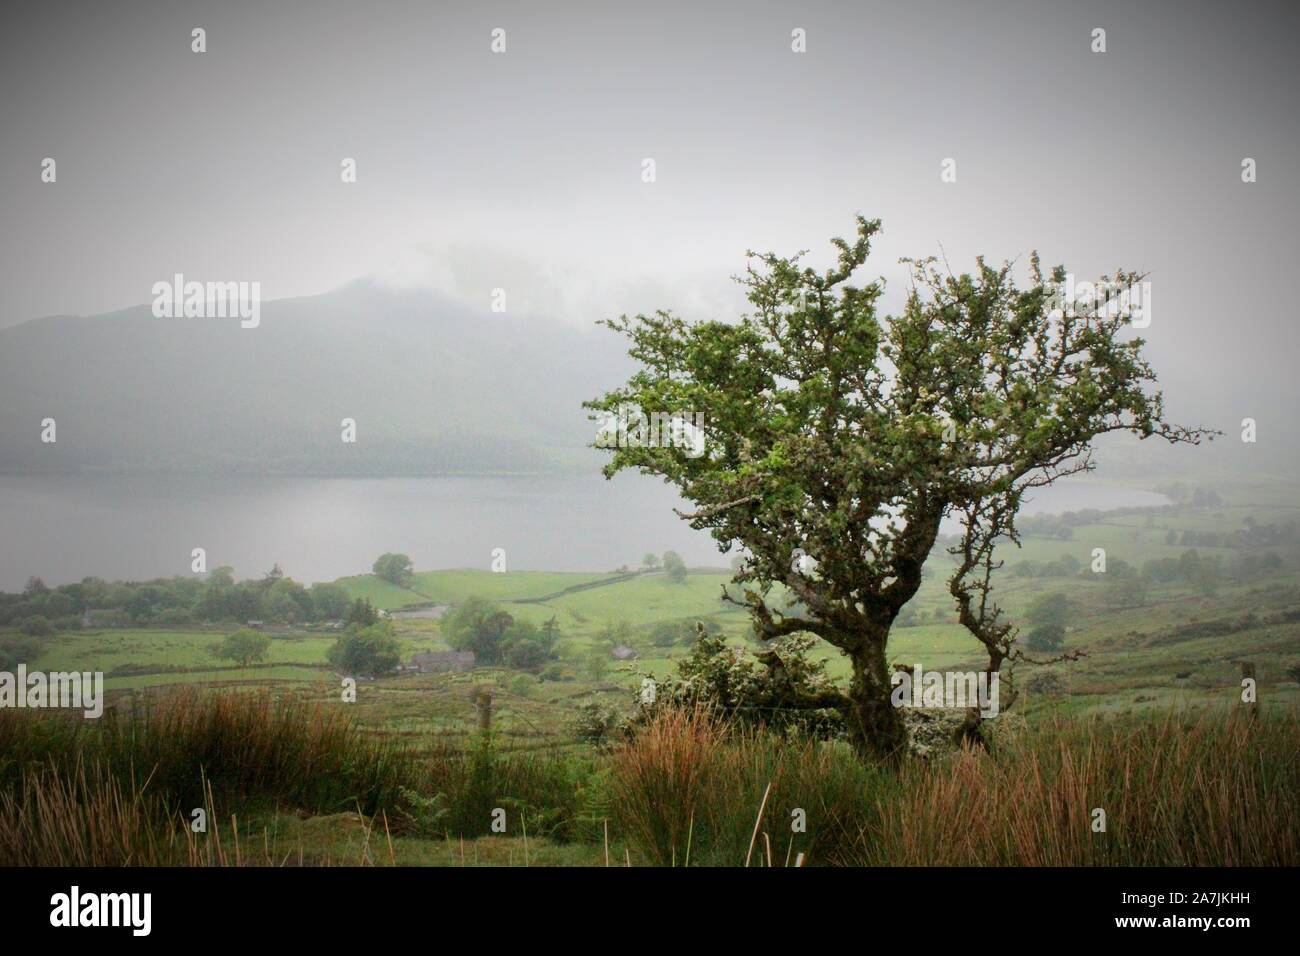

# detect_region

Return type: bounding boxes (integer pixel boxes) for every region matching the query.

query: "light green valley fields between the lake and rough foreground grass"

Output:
[25,476,1300,732]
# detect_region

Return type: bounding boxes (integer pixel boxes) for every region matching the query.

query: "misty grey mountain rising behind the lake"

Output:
[0,282,629,476]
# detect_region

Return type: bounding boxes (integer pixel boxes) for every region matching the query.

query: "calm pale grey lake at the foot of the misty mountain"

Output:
[0,475,1167,591]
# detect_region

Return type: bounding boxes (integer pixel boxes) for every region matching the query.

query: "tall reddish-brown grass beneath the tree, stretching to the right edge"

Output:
[612,710,1300,866]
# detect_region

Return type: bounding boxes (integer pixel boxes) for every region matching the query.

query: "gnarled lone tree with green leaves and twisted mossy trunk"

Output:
[586,216,1206,760]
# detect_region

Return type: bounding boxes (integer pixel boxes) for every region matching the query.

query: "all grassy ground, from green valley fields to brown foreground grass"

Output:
[0,481,1300,866]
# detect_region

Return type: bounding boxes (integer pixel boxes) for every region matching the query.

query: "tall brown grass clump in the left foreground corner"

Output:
[0,688,415,866]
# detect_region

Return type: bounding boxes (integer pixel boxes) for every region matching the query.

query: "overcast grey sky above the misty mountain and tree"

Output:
[0,0,1300,434]
